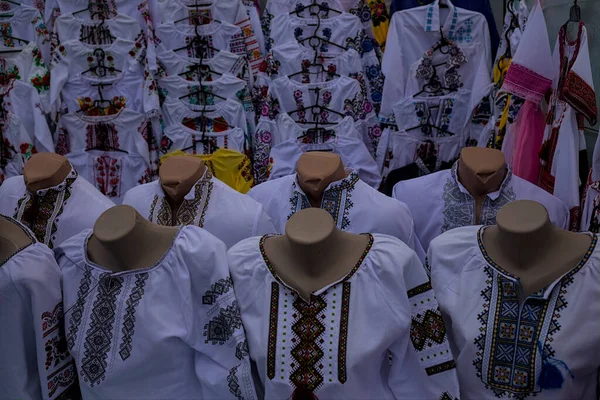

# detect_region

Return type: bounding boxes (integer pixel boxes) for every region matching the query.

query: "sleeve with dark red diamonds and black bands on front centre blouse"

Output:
[405,258,460,399]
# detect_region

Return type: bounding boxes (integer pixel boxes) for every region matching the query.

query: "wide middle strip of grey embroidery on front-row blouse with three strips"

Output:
[80,274,123,387]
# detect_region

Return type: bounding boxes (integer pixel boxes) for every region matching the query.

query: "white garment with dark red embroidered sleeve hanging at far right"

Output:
[539,22,598,231]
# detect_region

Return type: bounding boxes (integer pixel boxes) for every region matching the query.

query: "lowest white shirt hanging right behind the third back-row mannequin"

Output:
[269,131,381,188]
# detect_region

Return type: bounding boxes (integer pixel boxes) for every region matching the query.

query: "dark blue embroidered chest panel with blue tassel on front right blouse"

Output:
[473,234,597,399]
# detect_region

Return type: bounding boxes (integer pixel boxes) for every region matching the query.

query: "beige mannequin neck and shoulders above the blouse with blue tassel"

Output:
[483,200,592,296]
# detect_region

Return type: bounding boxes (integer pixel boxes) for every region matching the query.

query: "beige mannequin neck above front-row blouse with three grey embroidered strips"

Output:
[87,206,178,272]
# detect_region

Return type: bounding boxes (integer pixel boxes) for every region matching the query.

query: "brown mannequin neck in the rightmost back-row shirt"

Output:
[458,147,507,223]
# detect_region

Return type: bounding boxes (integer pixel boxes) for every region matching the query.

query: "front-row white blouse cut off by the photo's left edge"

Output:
[0,216,79,400]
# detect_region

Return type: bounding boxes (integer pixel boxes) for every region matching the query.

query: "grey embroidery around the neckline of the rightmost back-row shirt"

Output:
[441,163,517,233]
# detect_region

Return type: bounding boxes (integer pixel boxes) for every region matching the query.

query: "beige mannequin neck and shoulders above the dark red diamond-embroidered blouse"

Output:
[264,208,369,301]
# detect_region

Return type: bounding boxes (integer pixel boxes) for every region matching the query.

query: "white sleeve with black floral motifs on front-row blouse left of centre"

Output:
[182,231,256,399]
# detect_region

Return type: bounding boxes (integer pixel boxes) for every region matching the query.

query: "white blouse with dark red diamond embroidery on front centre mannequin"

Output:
[228,234,459,399]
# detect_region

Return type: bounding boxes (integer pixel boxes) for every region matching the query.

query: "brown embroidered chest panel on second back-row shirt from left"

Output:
[148,178,213,228]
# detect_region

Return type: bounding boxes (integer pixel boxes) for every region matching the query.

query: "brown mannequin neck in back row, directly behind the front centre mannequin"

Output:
[296,151,348,208]
